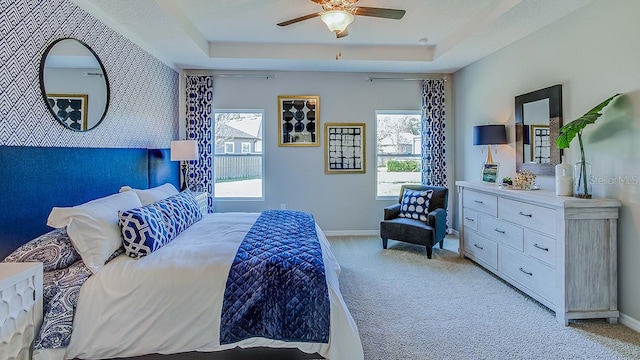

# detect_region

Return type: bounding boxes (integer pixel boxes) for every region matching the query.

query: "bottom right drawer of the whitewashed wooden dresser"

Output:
[500,246,557,304]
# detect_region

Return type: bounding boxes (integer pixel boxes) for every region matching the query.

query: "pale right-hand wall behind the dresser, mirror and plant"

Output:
[454,0,640,331]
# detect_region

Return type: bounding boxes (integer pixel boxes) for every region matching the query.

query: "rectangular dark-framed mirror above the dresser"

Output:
[515,85,562,175]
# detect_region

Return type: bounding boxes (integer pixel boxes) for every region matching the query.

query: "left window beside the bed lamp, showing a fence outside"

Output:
[214,110,264,200]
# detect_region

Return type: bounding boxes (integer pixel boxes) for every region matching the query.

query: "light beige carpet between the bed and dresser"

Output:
[329,237,640,360]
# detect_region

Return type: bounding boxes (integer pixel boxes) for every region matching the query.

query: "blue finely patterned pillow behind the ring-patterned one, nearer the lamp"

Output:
[151,191,202,239]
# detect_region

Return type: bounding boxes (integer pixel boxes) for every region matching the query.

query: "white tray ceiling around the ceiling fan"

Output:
[73,0,591,73]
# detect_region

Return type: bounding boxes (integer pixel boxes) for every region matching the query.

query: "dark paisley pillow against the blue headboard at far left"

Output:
[3,229,80,271]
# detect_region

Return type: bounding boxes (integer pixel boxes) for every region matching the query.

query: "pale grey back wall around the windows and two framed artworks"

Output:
[182,71,453,233]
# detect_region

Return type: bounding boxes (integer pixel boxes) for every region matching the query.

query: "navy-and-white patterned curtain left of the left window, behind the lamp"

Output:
[186,75,214,212]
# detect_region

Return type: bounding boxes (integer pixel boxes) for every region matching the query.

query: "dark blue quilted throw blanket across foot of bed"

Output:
[220,210,329,344]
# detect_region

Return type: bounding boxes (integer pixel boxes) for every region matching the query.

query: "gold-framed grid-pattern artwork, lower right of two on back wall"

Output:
[324,123,366,174]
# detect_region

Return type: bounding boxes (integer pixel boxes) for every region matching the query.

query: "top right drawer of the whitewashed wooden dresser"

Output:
[498,198,556,236]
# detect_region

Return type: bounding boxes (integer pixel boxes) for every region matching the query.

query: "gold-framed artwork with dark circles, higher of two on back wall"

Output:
[278,95,320,146]
